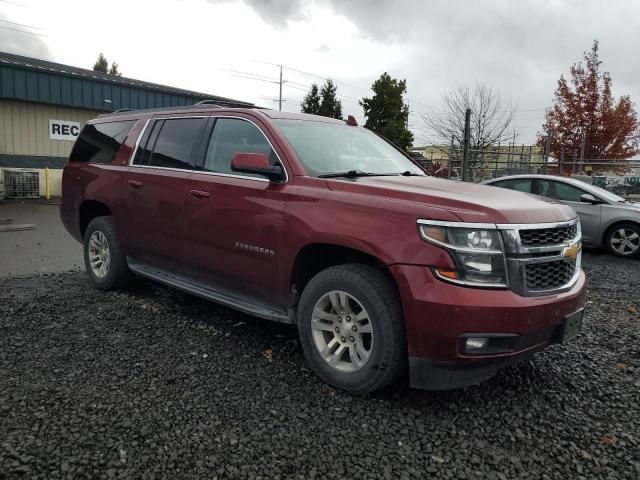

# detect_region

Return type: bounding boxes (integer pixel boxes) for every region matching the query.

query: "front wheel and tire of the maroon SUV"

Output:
[298,264,406,394]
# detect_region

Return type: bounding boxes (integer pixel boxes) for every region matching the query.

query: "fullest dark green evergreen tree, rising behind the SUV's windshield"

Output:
[360,72,413,150]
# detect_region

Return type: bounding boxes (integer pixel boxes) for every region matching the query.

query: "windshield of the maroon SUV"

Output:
[275,120,424,176]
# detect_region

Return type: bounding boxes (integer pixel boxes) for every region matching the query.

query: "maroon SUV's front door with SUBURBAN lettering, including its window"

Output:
[185,117,287,304]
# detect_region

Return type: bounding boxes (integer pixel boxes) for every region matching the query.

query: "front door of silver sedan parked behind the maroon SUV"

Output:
[536,179,602,244]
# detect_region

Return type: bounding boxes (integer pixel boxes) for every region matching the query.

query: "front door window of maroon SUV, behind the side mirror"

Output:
[204,118,278,177]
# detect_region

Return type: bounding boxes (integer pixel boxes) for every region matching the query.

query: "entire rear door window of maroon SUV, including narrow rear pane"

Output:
[133,118,204,170]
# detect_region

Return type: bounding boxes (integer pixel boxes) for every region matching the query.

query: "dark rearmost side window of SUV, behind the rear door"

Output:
[69,120,136,163]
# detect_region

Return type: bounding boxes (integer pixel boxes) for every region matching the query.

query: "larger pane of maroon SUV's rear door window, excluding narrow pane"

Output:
[149,118,204,170]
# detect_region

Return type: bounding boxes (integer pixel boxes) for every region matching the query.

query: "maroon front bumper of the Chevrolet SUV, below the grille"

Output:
[391,265,586,389]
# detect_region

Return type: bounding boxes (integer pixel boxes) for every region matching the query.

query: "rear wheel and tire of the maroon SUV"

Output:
[84,217,131,290]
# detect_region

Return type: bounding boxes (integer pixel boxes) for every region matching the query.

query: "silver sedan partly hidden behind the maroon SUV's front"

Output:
[484,175,640,257]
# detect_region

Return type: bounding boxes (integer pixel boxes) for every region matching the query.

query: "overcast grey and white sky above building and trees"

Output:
[0,0,640,145]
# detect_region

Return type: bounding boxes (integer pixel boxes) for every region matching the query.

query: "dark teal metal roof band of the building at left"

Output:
[0,52,252,112]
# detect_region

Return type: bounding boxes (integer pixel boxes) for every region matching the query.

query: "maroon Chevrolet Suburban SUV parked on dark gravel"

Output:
[61,104,585,393]
